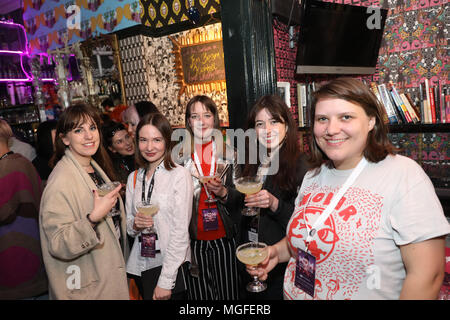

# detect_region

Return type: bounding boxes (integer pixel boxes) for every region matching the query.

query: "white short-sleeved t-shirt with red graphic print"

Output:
[284,155,450,299]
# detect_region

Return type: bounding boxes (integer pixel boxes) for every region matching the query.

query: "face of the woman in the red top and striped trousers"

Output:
[188,101,214,141]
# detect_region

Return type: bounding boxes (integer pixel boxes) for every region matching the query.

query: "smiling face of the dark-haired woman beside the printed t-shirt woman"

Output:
[255,108,287,149]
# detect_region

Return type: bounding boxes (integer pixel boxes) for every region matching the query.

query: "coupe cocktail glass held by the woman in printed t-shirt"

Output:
[236,242,268,292]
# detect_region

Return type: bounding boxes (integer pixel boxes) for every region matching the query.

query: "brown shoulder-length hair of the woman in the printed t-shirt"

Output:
[310,77,398,168]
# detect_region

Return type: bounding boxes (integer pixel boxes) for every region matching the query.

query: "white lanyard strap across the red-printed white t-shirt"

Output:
[305,157,367,248]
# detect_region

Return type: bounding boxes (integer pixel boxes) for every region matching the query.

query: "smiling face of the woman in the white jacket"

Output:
[138,124,166,165]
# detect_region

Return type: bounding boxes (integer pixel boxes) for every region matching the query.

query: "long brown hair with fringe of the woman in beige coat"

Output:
[50,104,116,180]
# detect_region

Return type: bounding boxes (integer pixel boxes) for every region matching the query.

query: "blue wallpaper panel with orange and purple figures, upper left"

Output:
[23,0,141,53]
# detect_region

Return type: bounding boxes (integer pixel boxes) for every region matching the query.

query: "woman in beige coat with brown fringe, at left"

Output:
[40,105,129,299]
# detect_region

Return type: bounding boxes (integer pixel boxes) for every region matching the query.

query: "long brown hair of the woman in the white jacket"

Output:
[135,113,175,170]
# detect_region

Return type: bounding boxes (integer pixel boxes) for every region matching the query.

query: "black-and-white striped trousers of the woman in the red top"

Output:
[188,238,239,300]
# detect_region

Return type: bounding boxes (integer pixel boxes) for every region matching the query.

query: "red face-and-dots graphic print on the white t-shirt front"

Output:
[285,184,382,299]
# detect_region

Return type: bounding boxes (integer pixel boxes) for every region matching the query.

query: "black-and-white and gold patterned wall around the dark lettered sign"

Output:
[120,24,228,127]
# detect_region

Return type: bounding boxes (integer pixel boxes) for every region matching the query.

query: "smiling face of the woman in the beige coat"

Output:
[61,118,100,164]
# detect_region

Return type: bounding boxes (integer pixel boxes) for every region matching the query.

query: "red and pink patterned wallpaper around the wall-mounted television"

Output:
[274,0,450,188]
